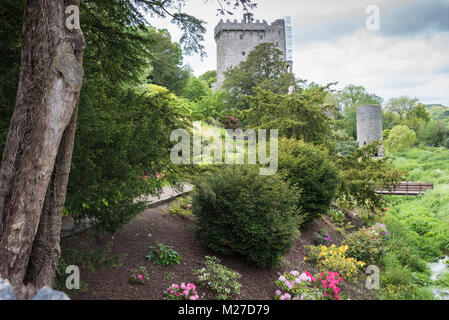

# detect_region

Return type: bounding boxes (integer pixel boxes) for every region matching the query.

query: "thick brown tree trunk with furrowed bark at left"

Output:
[0,0,85,298]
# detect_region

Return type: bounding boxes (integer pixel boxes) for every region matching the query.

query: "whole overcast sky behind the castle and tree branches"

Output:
[150,0,449,106]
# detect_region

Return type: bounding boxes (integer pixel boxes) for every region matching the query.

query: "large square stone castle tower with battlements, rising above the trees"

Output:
[214,14,293,89]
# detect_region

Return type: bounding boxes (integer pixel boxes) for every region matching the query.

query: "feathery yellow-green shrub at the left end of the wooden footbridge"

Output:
[335,142,404,211]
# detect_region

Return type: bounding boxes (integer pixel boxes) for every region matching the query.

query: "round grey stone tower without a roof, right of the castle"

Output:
[357,105,382,147]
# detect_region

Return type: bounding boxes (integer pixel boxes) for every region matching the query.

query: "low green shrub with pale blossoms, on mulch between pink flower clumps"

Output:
[193,256,242,300]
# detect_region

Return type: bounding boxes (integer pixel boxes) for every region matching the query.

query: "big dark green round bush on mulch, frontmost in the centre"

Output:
[192,165,301,267]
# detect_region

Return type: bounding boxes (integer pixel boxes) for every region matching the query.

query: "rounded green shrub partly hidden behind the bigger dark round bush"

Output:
[279,139,339,223]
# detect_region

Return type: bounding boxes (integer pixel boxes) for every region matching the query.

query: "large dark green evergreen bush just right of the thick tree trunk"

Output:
[66,83,191,232]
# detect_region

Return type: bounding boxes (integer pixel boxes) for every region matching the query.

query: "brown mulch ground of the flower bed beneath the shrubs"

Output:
[63,200,374,300]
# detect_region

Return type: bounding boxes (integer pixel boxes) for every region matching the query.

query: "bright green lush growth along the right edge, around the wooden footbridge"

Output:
[379,148,449,299]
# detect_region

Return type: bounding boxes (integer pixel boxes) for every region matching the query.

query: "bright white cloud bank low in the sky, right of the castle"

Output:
[294,29,449,105]
